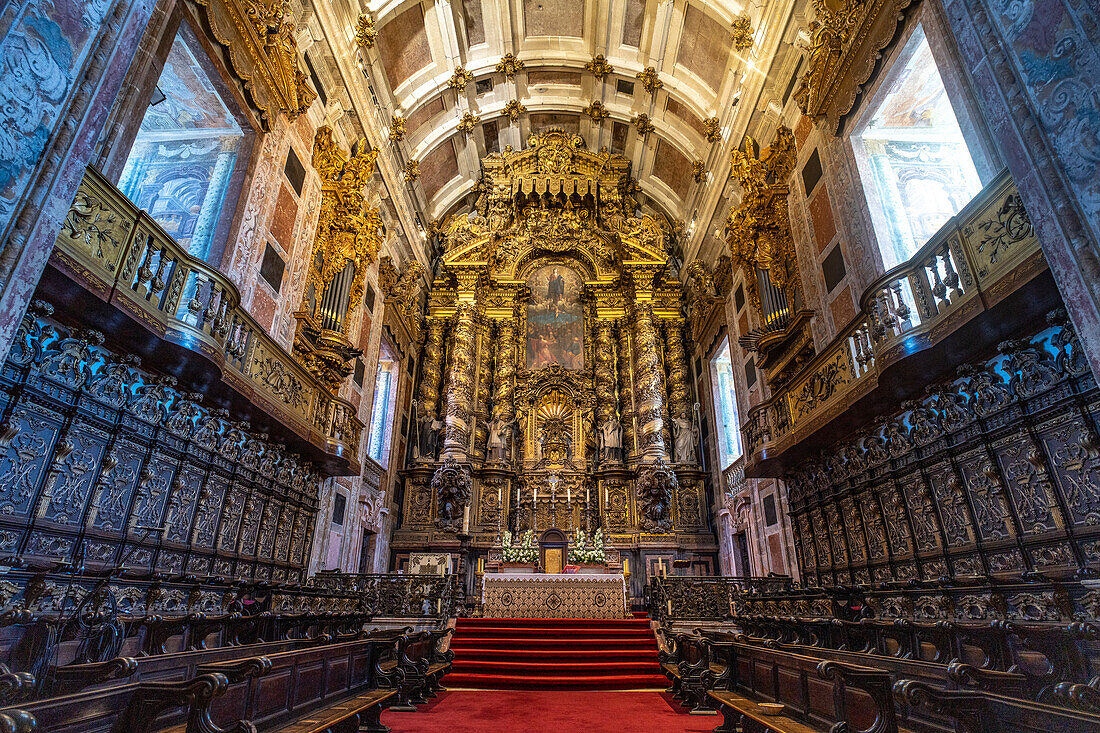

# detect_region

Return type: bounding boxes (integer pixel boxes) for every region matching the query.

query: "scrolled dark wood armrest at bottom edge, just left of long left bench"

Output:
[119,672,256,733]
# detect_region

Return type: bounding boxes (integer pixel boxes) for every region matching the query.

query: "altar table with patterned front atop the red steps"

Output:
[482,572,627,619]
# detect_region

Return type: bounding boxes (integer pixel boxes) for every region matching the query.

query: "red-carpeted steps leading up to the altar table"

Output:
[443,619,668,690]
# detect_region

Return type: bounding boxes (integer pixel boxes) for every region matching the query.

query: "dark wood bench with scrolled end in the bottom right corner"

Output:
[893,679,1100,733]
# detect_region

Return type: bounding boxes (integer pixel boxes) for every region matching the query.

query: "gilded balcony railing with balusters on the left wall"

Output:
[52,167,363,472]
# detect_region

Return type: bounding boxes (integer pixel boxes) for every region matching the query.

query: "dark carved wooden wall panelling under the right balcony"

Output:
[787,315,1100,581]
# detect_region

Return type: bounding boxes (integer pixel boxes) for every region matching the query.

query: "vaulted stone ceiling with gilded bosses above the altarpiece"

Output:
[305,0,793,265]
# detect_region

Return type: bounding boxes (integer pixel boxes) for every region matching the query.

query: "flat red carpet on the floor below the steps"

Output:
[382,677,722,733]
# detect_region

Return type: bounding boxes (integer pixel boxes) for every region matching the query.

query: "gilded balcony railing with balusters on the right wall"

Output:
[741,171,1046,467]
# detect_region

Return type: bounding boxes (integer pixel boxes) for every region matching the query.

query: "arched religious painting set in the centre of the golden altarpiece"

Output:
[527,264,584,370]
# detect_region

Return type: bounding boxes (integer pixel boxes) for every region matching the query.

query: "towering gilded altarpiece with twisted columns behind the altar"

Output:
[393,130,715,560]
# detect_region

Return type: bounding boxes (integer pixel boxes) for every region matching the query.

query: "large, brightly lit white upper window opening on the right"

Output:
[851,26,981,270]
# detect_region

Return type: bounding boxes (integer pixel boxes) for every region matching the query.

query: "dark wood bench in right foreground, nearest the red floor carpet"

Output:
[707,642,902,733]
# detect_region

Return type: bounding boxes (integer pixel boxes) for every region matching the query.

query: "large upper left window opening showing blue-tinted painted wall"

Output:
[119,31,244,264]
